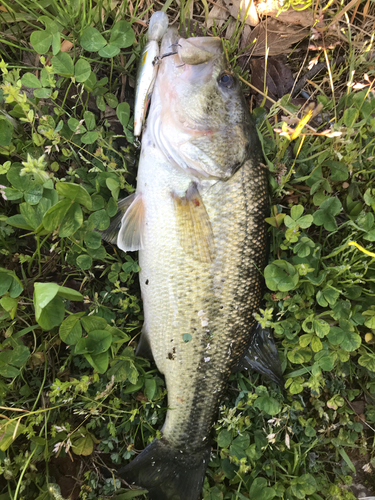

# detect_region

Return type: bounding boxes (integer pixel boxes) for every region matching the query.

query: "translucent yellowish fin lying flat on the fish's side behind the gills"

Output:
[173,182,215,263]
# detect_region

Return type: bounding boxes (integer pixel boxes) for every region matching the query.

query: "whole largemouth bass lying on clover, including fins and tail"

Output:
[103,22,282,500]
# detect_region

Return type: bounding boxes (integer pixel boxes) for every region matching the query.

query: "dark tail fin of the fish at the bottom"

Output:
[117,438,211,500]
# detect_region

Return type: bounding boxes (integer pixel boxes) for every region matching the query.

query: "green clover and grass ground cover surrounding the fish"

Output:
[0,0,375,500]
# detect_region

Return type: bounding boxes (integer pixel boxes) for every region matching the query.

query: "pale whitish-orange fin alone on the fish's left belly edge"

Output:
[117,193,145,252]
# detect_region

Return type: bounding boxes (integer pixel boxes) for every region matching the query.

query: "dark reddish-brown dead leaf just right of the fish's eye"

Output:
[250,57,294,104]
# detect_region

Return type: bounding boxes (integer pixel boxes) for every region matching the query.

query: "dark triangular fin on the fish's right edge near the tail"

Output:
[236,323,285,389]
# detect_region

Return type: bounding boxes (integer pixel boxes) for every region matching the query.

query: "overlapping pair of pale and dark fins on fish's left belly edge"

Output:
[101,193,145,252]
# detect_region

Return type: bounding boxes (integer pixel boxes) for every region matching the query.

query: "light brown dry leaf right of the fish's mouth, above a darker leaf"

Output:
[246,18,310,56]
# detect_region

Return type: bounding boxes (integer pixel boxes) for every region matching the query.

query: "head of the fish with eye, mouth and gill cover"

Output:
[155,28,257,179]
